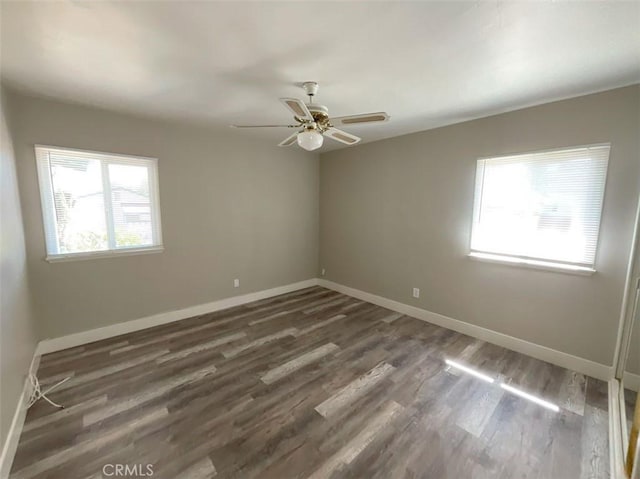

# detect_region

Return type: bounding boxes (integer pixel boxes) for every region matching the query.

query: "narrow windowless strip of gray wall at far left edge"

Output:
[0,91,36,452]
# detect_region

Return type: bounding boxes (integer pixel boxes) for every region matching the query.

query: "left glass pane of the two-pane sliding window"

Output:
[50,154,108,253]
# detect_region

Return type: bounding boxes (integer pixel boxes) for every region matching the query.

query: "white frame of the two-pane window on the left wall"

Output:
[34,144,164,263]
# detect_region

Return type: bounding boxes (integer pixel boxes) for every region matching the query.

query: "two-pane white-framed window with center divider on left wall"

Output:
[36,146,162,260]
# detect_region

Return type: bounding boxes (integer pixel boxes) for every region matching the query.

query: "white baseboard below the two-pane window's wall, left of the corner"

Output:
[36,278,318,355]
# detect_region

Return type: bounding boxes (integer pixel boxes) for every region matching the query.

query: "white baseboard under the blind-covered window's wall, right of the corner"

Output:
[318,279,613,381]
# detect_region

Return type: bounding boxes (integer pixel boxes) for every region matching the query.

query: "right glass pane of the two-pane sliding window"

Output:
[109,164,153,248]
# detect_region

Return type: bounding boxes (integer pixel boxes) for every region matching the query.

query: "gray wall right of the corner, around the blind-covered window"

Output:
[320,86,640,365]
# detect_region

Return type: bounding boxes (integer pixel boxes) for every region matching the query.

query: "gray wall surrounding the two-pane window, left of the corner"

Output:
[11,95,319,338]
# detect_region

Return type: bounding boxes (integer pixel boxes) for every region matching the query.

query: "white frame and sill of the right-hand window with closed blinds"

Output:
[466,142,611,276]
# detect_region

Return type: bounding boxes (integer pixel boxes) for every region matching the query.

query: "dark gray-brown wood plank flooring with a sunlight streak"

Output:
[11,287,609,479]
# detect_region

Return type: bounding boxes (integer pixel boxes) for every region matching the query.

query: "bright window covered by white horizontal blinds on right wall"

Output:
[471,145,610,272]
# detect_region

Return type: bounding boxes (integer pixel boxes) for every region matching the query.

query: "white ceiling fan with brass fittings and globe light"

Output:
[231,82,389,151]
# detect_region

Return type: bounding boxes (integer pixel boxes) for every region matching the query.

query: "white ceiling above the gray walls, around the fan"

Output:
[0,0,640,150]
